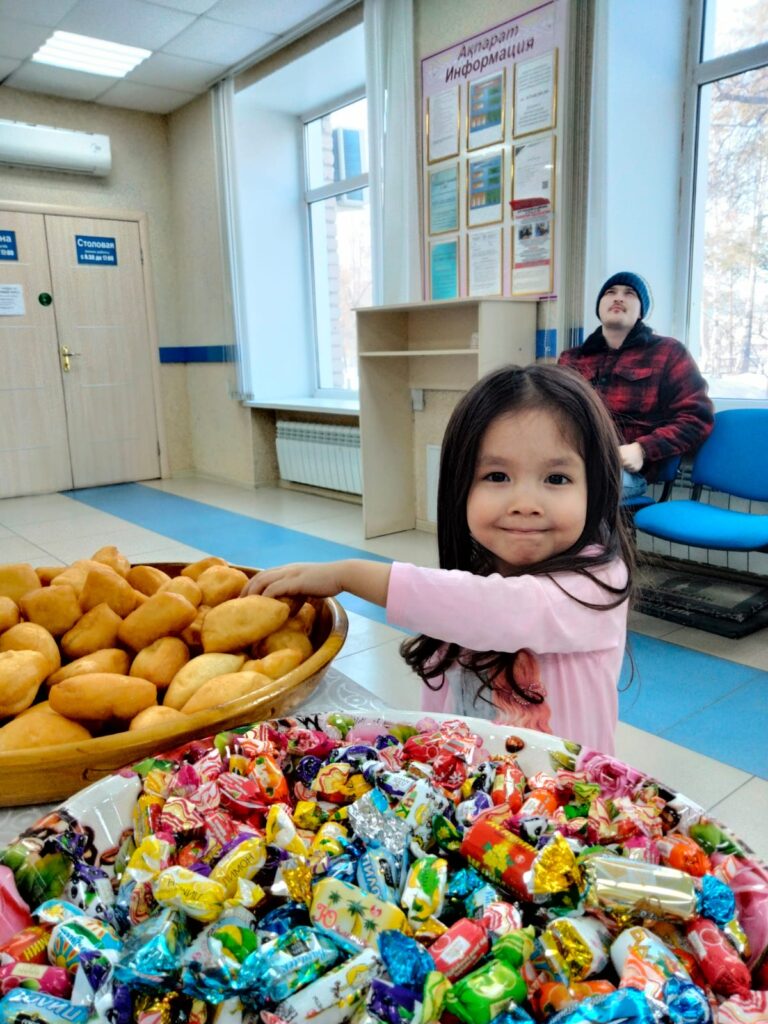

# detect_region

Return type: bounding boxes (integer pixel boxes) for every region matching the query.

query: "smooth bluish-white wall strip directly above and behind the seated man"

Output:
[584,0,688,338]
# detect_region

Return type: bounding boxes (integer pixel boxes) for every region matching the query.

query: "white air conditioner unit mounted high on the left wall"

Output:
[0,120,112,177]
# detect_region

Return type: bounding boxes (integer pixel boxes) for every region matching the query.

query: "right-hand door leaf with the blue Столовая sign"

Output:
[45,215,160,487]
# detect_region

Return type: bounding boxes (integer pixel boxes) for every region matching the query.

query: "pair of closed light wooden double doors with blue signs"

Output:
[0,209,161,498]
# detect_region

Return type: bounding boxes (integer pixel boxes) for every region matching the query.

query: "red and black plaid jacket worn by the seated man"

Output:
[557,321,714,480]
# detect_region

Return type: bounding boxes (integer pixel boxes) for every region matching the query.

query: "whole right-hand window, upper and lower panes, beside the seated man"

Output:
[690,0,768,401]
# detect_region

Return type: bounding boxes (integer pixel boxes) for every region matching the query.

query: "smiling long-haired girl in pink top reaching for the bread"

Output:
[246,365,633,754]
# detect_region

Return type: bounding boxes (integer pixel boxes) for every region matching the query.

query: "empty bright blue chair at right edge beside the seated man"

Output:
[635,409,768,551]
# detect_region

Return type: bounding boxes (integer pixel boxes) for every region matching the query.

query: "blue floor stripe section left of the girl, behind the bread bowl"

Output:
[61,483,391,623]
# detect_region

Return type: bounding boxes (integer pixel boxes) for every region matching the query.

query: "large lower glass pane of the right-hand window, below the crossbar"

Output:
[692,68,768,399]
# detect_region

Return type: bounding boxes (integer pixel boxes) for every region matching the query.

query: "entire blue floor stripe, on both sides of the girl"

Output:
[63,483,768,778]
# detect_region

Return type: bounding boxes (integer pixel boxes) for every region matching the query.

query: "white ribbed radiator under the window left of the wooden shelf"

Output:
[278,420,362,495]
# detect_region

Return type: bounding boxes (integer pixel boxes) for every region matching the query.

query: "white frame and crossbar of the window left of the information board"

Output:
[299,87,373,399]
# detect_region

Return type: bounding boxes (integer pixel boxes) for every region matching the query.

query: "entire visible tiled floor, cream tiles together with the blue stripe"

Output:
[0,478,768,858]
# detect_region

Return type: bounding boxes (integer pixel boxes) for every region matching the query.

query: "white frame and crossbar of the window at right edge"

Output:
[675,0,768,399]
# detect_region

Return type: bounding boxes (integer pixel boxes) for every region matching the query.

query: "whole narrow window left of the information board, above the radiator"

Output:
[304,98,372,392]
